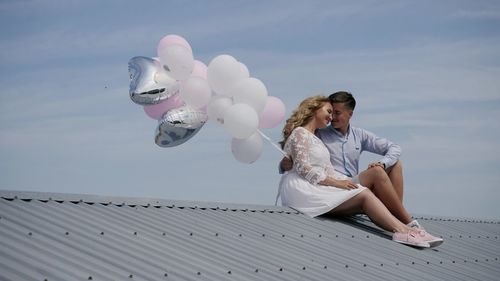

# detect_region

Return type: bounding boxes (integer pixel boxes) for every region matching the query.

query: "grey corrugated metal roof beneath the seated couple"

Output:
[0,191,500,281]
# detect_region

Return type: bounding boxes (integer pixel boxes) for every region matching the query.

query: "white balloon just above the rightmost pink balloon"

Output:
[230,77,267,113]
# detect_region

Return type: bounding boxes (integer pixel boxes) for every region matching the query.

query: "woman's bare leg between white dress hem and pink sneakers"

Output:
[330,189,409,232]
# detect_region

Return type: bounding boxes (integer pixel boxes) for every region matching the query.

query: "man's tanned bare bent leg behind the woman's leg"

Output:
[359,167,412,224]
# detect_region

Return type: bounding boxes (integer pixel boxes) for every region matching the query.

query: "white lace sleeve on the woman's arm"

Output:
[285,127,326,184]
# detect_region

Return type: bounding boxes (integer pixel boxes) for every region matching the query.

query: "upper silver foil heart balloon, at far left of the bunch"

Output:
[128,57,179,105]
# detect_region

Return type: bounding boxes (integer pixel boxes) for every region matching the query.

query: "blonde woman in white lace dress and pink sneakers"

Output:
[279,96,442,248]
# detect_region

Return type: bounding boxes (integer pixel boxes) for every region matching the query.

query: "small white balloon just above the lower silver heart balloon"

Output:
[179,76,212,108]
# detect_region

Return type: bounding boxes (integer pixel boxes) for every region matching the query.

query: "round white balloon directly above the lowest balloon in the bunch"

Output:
[224,103,259,139]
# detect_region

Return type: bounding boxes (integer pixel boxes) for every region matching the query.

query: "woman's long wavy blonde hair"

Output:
[280,95,330,148]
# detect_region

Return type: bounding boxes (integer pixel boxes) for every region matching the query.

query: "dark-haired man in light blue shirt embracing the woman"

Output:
[280,91,422,228]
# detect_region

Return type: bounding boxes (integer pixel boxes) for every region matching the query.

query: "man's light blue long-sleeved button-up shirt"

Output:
[316,126,401,177]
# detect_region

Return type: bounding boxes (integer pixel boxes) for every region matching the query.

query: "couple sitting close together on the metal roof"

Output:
[278,92,443,248]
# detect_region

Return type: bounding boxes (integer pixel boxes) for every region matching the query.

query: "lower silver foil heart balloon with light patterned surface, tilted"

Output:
[155,105,208,147]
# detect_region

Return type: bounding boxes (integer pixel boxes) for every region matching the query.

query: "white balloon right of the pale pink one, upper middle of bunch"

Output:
[207,55,244,95]
